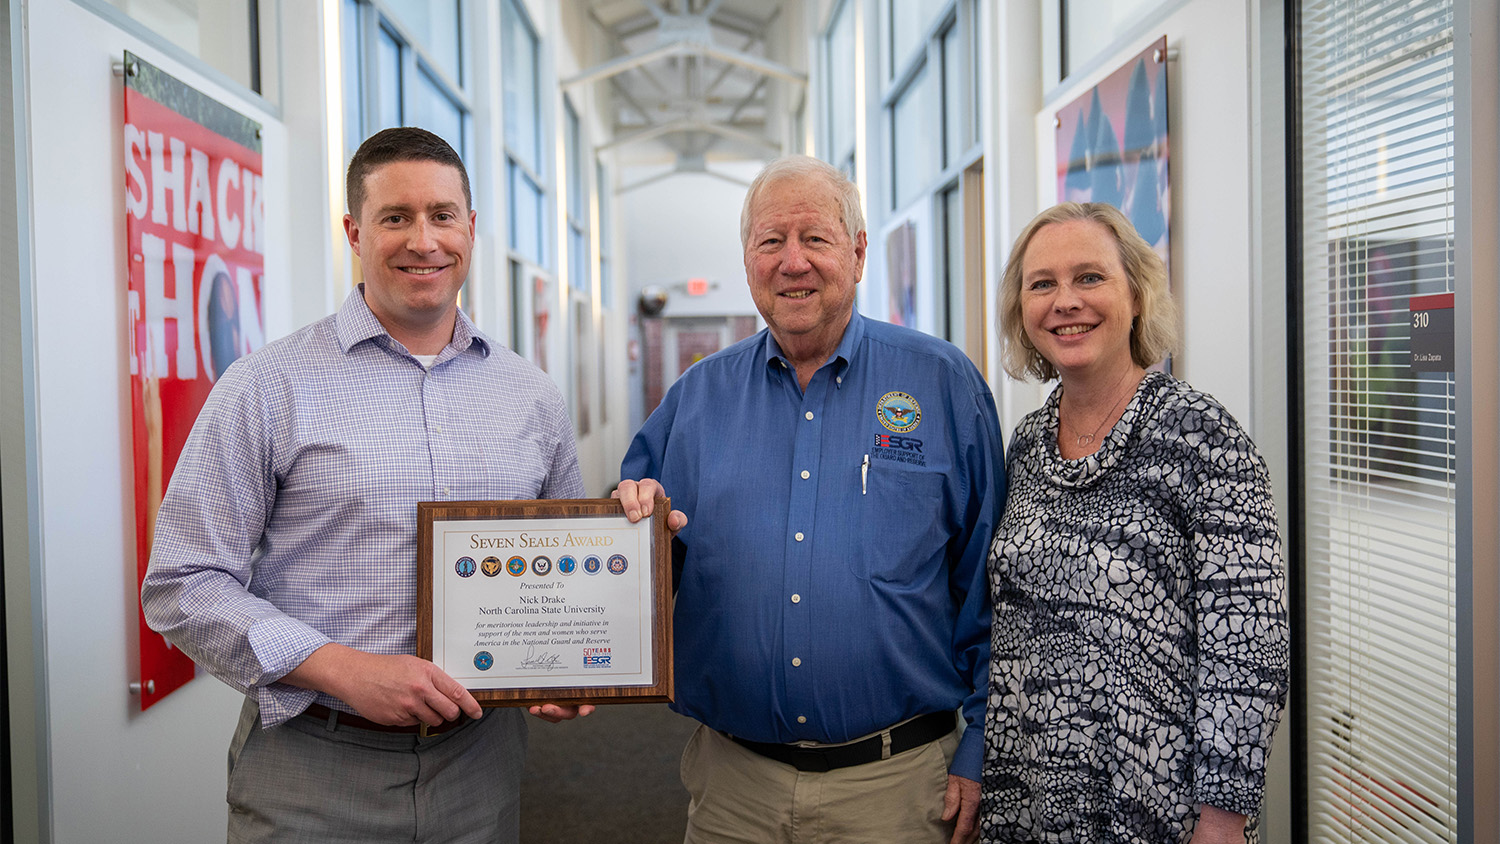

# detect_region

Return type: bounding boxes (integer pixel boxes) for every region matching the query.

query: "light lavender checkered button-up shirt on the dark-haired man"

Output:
[141,288,584,727]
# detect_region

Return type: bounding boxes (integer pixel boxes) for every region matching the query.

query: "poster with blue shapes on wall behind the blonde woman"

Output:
[1055,36,1172,277]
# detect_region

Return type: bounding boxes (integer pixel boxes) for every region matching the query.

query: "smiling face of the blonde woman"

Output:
[1022,220,1140,382]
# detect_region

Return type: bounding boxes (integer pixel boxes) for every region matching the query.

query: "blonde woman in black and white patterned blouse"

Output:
[981,202,1287,844]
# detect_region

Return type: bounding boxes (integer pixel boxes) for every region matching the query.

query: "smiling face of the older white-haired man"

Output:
[746,177,866,360]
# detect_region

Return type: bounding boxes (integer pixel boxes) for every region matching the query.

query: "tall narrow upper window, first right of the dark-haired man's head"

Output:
[501,0,548,265]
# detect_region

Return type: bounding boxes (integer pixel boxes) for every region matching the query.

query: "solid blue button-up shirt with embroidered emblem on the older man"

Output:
[621,313,1005,780]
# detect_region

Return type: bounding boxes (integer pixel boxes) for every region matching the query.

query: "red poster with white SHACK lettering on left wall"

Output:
[122,52,266,709]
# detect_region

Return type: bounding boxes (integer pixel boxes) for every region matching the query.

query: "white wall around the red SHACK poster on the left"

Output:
[8,0,329,843]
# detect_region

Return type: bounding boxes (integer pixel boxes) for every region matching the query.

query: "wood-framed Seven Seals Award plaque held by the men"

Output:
[417,498,672,706]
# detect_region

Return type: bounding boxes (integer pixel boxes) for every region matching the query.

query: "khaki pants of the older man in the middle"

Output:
[683,726,962,844]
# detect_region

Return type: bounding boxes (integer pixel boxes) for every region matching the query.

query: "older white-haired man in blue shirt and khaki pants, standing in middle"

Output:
[621,156,1005,843]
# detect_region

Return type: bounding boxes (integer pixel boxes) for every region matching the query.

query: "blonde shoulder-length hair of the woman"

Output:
[1001,202,1178,381]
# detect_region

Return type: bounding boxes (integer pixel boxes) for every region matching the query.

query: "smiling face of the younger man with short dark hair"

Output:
[344,160,474,354]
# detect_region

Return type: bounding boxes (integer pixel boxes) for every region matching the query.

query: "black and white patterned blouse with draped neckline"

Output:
[981,372,1289,844]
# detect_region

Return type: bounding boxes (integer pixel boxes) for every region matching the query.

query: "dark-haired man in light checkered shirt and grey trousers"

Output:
[141,127,669,843]
